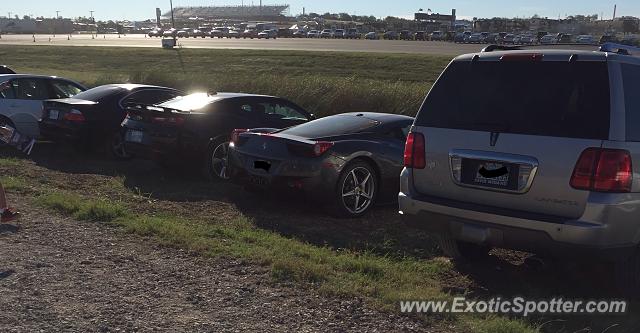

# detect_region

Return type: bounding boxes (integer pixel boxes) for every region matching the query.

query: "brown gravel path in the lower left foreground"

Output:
[0,197,436,332]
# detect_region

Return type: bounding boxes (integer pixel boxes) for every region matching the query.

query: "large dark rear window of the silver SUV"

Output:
[416,61,610,140]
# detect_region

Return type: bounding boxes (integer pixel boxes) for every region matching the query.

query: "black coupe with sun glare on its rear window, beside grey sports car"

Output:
[123,93,313,179]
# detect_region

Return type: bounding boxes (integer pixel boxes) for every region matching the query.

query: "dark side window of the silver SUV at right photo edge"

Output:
[622,64,640,141]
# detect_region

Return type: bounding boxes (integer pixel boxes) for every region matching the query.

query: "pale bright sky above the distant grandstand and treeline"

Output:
[5,0,640,20]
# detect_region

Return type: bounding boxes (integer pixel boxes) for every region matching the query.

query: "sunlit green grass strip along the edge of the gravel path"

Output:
[31,185,535,333]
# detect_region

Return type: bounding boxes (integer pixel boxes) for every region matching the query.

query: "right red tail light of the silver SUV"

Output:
[571,148,633,193]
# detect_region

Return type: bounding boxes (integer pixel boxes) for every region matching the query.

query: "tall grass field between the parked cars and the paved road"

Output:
[0,45,450,116]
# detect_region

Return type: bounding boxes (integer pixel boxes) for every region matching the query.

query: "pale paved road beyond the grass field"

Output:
[0,35,496,55]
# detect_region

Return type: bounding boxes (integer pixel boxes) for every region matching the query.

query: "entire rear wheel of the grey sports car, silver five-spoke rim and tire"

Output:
[337,161,378,217]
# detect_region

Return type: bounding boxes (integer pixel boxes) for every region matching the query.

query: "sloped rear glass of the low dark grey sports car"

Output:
[281,115,380,138]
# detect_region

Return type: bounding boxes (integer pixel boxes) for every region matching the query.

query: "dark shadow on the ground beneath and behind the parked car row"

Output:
[8,145,640,332]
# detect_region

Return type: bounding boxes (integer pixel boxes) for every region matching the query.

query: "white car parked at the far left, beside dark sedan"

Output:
[0,74,87,138]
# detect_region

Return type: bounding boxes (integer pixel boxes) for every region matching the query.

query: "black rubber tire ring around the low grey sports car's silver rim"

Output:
[333,160,380,218]
